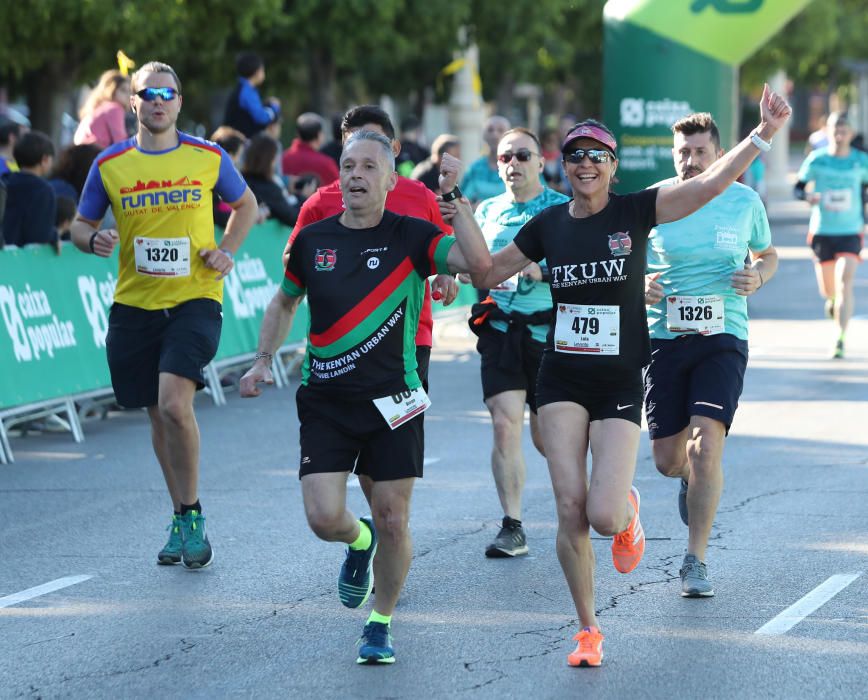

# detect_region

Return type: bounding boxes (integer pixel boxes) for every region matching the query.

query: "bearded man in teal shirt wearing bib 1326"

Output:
[645,113,778,598]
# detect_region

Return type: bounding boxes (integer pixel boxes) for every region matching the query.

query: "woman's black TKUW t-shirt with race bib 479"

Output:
[514,189,657,372]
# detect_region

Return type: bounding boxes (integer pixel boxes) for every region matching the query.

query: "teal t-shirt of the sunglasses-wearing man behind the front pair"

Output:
[476,187,570,343]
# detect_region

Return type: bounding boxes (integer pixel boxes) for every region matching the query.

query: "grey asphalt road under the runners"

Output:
[0,200,868,698]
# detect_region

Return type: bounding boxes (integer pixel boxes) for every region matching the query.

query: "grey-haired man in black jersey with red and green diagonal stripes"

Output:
[241,131,491,664]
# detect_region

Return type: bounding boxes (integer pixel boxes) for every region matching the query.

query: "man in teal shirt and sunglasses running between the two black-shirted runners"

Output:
[448,128,569,557]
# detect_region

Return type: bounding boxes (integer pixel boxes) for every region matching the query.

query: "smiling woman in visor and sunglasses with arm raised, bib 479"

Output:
[464,86,791,666]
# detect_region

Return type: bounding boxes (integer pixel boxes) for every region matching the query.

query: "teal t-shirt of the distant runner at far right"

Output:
[798,148,868,236]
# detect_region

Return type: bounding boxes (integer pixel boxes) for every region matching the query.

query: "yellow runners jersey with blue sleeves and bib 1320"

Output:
[79,132,247,310]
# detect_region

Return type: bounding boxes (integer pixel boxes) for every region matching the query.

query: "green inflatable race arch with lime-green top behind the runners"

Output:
[603,0,810,192]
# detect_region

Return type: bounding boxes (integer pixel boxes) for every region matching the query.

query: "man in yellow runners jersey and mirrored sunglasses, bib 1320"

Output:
[71,61,258,568]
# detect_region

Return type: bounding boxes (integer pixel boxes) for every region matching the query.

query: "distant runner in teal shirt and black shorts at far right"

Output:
[795,112,868,359]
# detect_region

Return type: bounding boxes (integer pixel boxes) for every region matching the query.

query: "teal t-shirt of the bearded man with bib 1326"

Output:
[648,179,772,340]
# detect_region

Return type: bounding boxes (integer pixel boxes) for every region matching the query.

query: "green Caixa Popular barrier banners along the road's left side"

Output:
[0,222,476,409]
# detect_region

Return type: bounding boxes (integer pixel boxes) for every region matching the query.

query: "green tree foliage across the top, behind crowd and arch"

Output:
[8,0,868,142]
